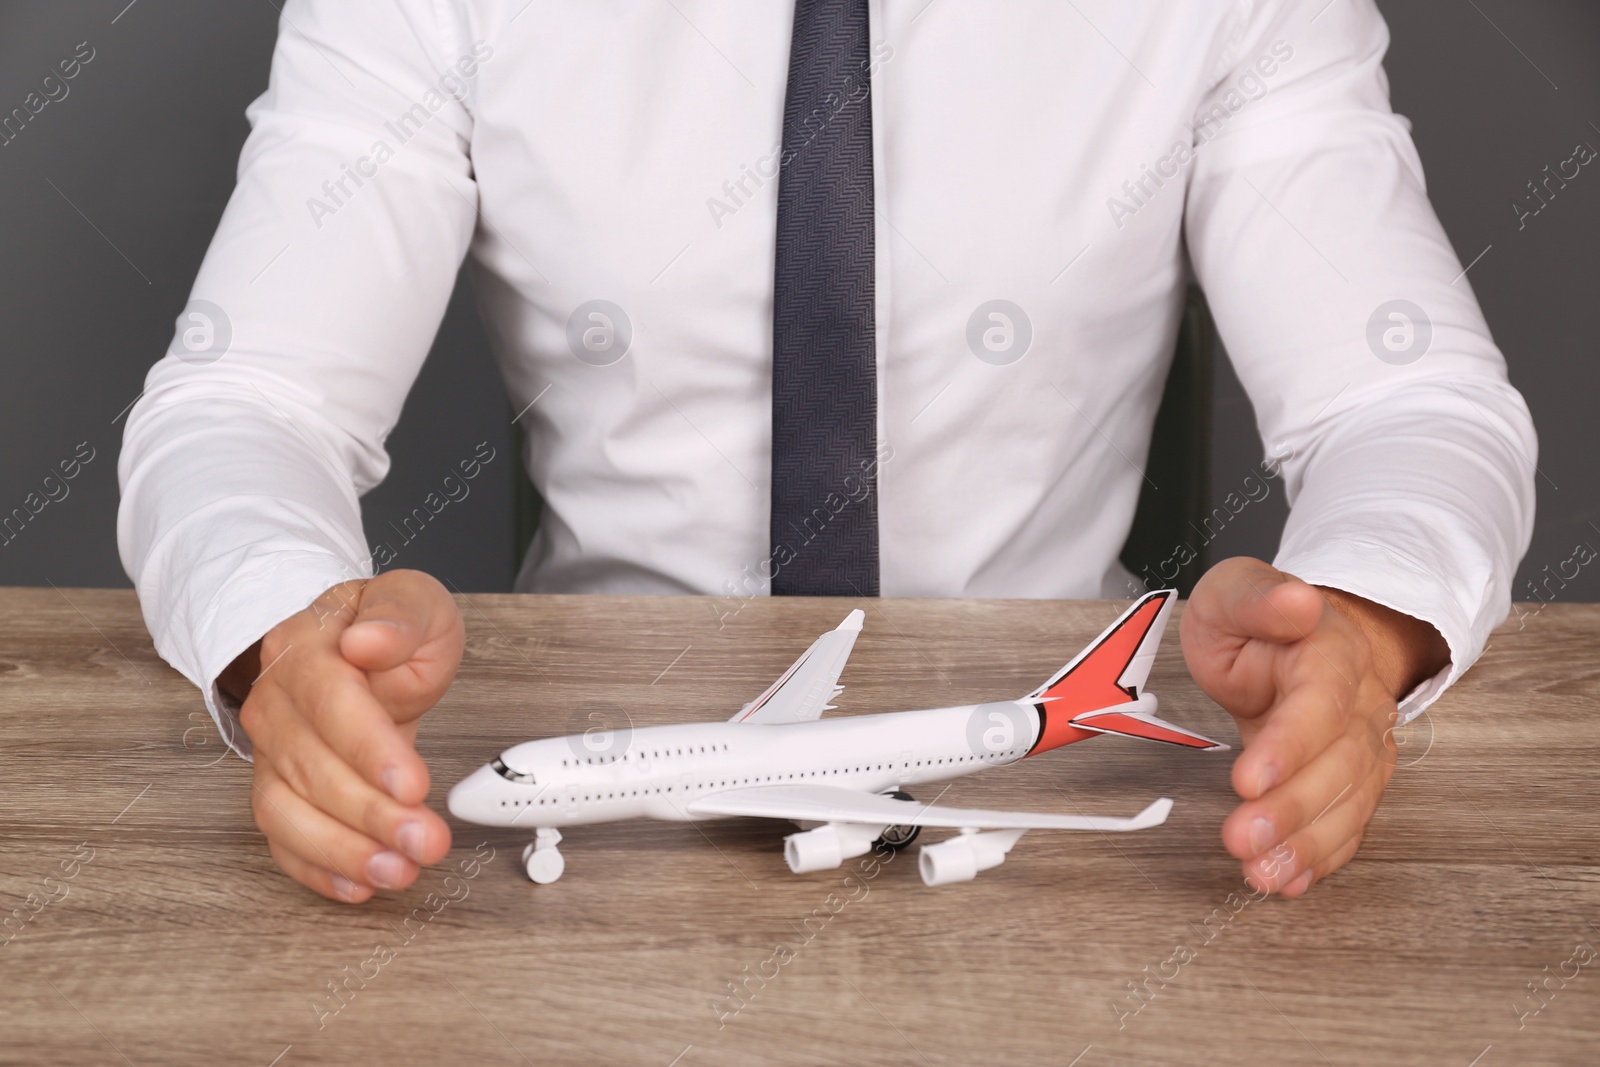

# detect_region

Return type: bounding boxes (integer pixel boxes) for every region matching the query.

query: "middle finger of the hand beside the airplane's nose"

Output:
[267,710,450,864]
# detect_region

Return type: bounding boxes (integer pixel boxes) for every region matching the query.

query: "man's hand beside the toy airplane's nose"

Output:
[218,571,466,904]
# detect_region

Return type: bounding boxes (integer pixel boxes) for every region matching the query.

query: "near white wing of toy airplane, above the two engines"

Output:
[688,785,1173,832]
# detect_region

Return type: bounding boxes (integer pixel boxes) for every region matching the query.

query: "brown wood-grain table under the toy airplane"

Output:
[0,589,1600,1067]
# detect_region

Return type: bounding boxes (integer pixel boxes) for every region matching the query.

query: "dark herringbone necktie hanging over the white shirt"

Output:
[771,0,878,597]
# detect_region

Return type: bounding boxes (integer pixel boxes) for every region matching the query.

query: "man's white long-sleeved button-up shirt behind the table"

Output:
[118,0,1536,750]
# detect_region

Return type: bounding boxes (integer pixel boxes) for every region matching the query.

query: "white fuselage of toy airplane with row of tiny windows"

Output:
[451,699,1062,829]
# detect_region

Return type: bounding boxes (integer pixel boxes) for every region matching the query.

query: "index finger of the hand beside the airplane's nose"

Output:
[264,649,429,805]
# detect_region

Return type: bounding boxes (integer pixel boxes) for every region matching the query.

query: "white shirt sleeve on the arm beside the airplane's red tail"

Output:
[1186,0,1538,721]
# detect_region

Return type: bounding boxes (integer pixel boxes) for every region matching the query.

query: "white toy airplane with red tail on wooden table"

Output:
[450,589,1227,886]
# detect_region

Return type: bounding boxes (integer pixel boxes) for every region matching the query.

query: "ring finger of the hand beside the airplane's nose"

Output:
[251,768,418,889]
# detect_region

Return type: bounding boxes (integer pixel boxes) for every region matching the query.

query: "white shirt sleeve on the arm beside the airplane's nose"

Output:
[117,0,491,757]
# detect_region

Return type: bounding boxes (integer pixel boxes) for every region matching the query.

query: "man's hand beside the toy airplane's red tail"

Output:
[1181,557,1450,897]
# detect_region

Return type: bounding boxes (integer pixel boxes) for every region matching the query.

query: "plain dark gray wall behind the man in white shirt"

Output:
[0,0,1600,600]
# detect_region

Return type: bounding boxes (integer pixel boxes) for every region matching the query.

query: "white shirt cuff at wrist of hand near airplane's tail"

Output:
[1272,541,1493,726]
